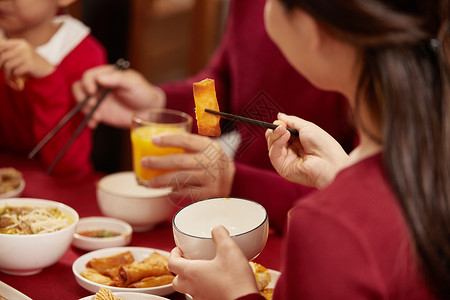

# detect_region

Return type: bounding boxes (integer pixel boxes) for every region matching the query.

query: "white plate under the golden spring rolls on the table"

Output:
[72,247,174,296]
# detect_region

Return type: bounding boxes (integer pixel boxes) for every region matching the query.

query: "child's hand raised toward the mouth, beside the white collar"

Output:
[0,39,55,78]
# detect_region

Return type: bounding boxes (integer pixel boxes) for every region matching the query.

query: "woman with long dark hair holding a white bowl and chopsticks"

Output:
[169,0,450,300]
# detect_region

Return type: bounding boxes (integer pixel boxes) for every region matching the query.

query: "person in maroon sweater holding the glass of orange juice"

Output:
[74,0,355,229]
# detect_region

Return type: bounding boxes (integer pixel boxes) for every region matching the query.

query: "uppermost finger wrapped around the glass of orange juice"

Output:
[152,133,214,152]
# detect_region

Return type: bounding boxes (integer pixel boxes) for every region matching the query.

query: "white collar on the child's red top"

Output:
[0,15,91,66]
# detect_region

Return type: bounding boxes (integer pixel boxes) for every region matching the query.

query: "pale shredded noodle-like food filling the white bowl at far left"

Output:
[0,205,74,235]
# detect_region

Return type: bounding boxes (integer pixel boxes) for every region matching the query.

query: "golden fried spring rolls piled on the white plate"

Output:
[81,251,175,288]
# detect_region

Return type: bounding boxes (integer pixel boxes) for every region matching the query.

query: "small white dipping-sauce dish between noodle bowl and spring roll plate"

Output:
[72,217,133,251]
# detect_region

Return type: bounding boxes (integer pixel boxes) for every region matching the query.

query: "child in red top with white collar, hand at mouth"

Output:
[0,0,106,174]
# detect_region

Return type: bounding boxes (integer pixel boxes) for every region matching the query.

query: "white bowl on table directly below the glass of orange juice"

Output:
[97,172,174,232]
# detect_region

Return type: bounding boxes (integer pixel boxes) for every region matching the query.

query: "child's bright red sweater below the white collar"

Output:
[0,36,106,174]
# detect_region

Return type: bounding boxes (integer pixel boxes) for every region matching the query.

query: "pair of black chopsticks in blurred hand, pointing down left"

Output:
[28,58,130,174]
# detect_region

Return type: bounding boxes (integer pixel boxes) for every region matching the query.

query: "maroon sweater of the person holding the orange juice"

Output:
[162,0,354,229]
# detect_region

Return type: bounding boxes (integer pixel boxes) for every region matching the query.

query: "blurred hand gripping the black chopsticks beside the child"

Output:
[72,65,166,128]
